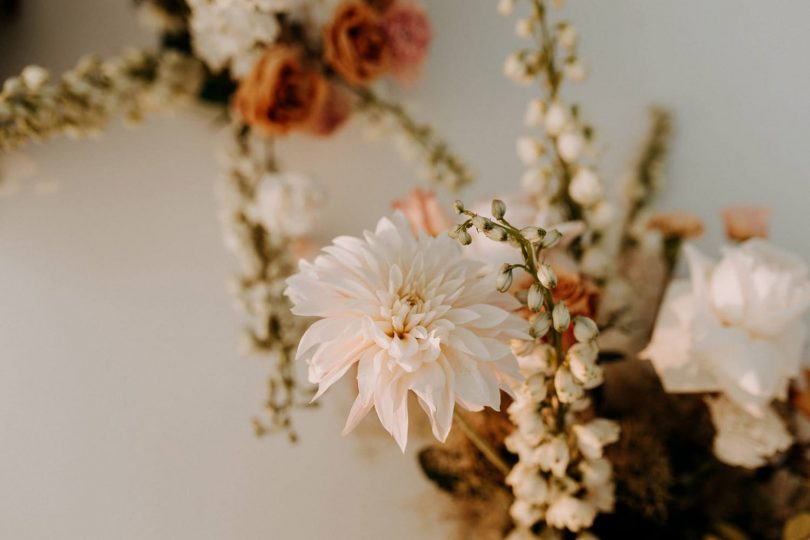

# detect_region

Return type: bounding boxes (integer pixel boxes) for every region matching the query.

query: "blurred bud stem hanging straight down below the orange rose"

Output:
[219,125,311,439]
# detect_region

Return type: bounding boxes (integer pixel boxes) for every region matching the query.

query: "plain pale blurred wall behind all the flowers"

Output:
[0,0,810,540]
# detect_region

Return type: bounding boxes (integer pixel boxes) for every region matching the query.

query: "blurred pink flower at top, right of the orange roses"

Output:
[383,3,432,80]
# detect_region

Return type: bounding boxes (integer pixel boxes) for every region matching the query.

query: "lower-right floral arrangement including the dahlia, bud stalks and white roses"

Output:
[285,0,810,540]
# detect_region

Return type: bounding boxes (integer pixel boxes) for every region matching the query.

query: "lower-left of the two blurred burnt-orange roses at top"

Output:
[234,45,349,135]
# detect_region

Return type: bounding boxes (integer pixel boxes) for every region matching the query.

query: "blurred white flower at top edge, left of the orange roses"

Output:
[189,0,280,78]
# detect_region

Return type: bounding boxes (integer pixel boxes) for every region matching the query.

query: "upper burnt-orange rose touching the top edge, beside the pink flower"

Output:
[324,0,391,86]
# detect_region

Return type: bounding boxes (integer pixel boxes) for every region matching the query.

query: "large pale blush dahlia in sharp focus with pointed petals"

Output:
[286,213,528,449]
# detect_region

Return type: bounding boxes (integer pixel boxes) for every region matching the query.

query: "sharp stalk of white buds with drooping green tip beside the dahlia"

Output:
[451,200,619,538]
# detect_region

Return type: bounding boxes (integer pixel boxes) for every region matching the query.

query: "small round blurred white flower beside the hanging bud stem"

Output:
[253,172,323,237]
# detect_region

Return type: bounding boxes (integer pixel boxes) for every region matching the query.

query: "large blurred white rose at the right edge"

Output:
[642,239,810,464]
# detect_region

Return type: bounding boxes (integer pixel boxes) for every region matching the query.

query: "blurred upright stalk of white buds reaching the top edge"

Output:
[499,0,617,278]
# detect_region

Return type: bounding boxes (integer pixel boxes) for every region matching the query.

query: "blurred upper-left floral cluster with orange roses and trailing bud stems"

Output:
[0,0,472,439]
